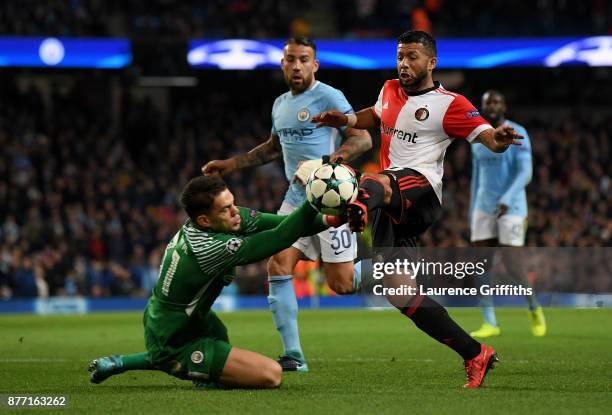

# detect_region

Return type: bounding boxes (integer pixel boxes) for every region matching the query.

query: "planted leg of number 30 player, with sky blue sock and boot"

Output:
[268,246,308,372]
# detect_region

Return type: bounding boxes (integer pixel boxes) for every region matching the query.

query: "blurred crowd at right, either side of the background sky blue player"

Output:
[428,118,612,247]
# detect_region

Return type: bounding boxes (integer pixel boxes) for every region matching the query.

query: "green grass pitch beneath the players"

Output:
[0,309,612,415]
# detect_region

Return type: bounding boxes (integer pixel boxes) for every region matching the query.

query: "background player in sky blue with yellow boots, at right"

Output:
[469,90,546,337]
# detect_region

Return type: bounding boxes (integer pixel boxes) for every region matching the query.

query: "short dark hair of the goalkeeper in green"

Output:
[180,176,227,222]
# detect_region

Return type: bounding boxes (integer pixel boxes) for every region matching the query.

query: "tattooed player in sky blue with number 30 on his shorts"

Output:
[202,36,372,372]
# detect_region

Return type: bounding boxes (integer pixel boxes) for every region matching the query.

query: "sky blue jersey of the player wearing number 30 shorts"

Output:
[272,81,353,206]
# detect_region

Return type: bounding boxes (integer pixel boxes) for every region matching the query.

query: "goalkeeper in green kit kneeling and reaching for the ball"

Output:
[89,176,350,388]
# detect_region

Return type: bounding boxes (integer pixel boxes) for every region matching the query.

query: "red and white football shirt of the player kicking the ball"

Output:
[372,79,493,203]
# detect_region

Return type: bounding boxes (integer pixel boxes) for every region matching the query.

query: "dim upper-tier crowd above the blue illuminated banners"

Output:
[0,0,612,38]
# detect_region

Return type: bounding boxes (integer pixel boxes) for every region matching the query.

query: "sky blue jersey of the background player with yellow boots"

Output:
[470,120,532,221]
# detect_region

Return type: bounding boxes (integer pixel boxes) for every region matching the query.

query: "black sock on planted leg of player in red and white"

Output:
[401,295,480,360]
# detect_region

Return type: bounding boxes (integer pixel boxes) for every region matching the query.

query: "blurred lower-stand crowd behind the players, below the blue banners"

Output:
[0,74,612,299]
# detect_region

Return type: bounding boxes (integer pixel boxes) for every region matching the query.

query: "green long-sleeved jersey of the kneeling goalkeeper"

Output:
[151,203,326,316]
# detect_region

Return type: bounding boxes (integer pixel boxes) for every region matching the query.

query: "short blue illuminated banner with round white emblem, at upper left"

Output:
[0,36,132,69]
